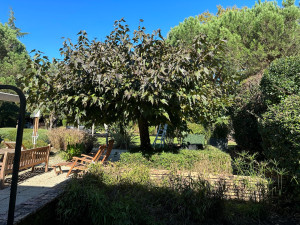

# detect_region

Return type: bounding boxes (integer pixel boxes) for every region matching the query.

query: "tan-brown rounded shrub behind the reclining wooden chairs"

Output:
[48,127,95,153]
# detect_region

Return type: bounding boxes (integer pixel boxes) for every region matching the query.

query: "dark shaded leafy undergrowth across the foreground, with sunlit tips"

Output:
[57,164,272,225]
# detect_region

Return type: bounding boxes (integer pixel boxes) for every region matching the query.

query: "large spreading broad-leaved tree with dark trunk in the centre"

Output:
[21,20,237,149]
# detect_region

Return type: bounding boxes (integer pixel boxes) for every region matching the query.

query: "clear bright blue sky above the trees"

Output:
[0,0,270,58]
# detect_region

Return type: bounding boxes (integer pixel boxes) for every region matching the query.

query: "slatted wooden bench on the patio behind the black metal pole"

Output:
[0,145,50,189]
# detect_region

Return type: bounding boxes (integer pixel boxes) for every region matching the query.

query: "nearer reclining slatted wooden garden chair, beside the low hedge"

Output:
[67,140,114,177]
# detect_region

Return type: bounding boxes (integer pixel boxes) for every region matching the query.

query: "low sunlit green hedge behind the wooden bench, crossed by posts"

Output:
[0,128,49,149]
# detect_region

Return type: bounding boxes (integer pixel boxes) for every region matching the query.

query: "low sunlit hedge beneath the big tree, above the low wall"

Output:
[119,146,232,174]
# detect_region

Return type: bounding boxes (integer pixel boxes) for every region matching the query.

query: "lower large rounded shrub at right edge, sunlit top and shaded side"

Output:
[259,95,300,174]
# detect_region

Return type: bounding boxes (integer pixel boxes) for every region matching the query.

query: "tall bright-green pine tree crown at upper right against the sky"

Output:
[168,0,300,78]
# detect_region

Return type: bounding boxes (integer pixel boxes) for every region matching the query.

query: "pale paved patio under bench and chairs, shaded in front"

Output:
[0,149,126,225]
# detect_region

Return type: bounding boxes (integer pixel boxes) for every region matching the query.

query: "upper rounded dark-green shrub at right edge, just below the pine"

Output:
[260,56,300,105]
